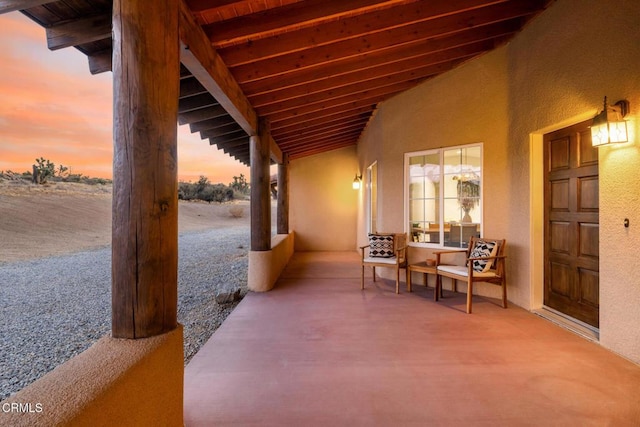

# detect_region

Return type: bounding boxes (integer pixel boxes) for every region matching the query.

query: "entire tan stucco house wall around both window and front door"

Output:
[358,0,640,363]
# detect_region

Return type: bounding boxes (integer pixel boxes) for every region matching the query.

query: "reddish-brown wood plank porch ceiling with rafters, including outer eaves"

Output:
[5,0,551,164]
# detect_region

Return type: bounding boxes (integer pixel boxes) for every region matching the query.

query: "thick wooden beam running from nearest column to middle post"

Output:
[180,1,258,135]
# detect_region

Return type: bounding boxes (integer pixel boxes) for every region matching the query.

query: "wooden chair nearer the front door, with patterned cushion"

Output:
[434,237,507,313]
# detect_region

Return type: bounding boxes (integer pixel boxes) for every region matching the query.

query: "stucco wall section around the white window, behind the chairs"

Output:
[358,45,510,297]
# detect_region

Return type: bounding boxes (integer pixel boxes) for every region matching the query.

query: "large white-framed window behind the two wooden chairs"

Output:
[405,144,482,248]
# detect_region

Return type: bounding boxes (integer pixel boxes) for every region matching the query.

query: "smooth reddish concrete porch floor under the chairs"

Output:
[184,253,640,427]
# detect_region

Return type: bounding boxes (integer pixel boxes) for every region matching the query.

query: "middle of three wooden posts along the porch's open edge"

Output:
[249,122,271,251]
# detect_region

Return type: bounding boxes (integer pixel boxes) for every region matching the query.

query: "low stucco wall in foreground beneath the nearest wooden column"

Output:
[0,325,184,427]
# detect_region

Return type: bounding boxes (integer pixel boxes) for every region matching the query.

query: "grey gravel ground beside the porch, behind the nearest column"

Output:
[0,226,249,400]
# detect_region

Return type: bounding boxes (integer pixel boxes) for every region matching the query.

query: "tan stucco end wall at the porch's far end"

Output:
[289,146,362,251]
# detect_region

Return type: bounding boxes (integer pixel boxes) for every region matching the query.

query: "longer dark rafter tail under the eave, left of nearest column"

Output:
[46,14,111,50]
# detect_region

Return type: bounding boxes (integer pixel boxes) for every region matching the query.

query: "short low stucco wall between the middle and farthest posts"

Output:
[247,232,294,292]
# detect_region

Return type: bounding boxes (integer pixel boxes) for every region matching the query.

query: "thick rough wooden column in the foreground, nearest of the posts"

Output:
[112,0,180,338]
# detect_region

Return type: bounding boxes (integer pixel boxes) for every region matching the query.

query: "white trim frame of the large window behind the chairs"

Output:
[403,142,485,249]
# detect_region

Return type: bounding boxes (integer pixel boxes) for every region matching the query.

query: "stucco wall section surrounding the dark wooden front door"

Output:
[508,0,640,363]
